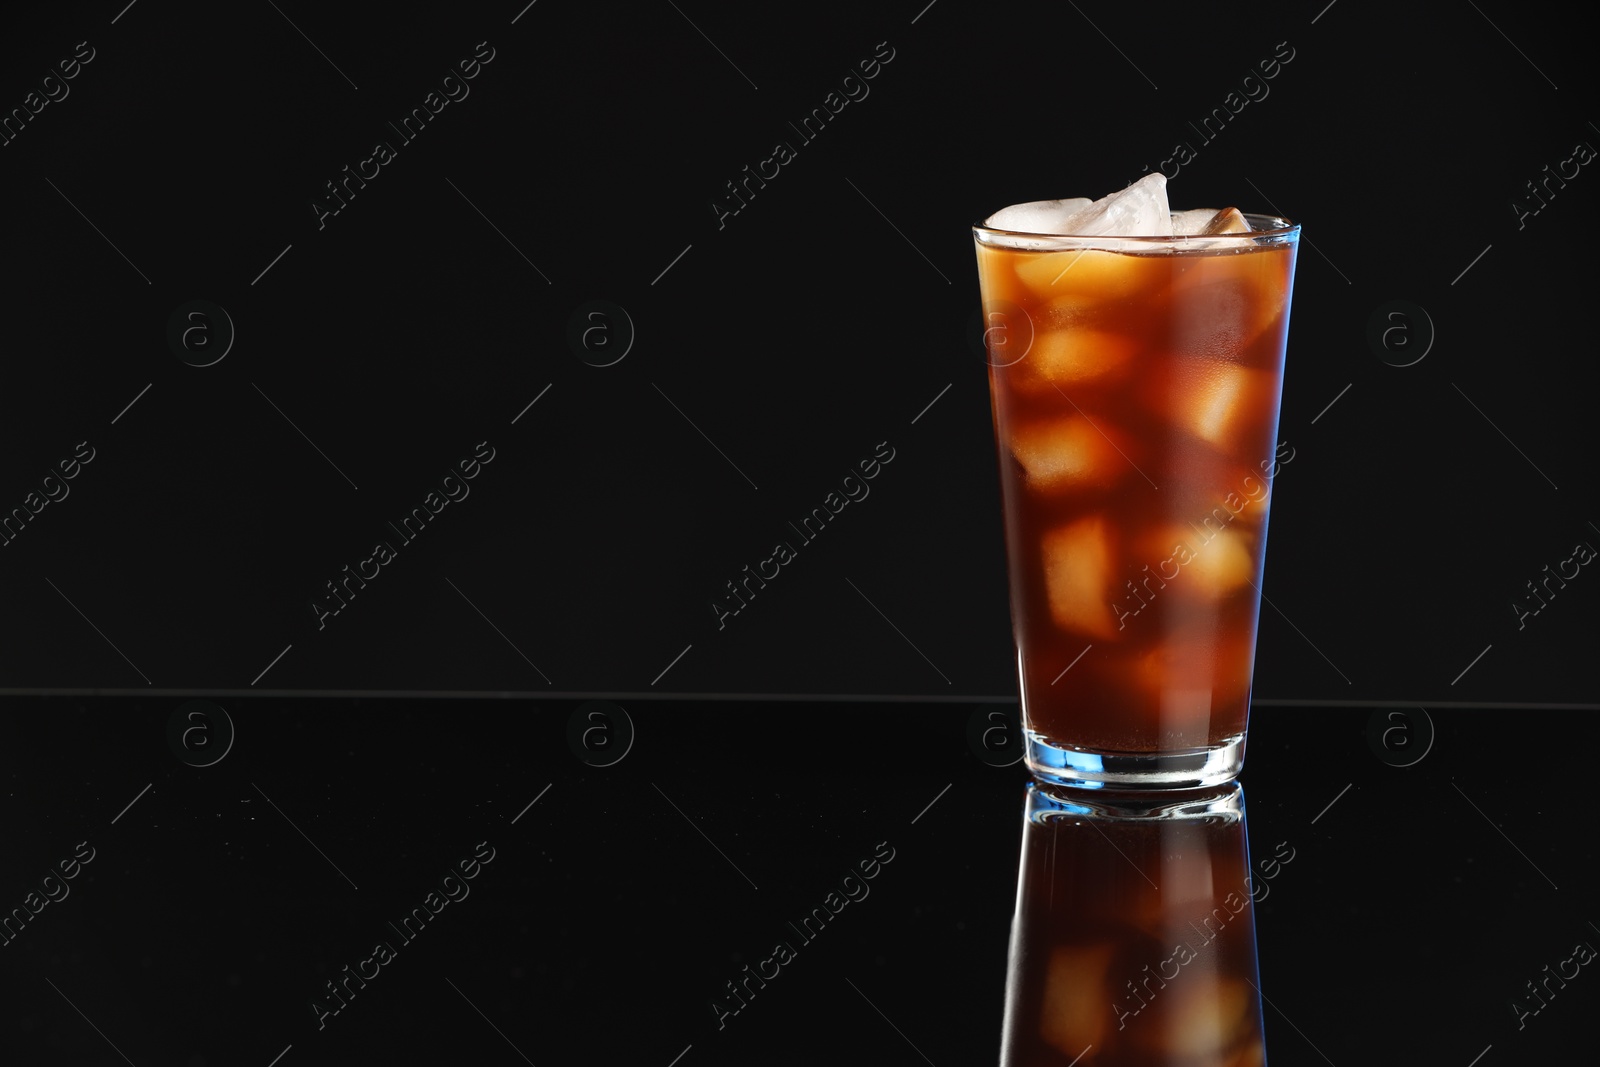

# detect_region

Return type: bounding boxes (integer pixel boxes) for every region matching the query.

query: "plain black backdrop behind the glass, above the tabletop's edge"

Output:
[0,0,1600,704]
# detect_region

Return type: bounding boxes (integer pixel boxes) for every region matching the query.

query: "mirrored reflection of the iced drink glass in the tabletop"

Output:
[1000,782,1266,1067]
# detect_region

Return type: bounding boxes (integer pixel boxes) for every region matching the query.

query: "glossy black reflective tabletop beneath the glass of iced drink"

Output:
[0,694,1600,1067]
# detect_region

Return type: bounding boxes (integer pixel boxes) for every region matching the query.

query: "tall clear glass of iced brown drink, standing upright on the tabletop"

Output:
[973,214,1299,789]
